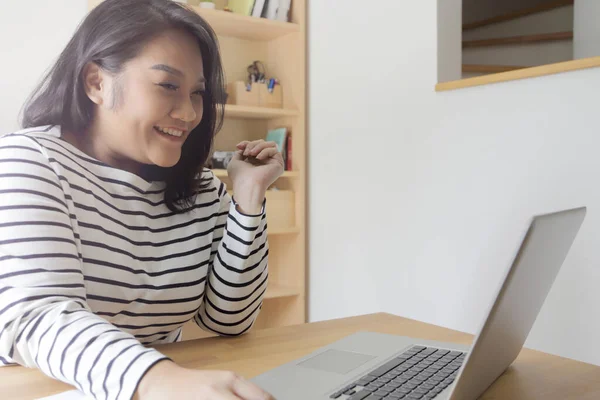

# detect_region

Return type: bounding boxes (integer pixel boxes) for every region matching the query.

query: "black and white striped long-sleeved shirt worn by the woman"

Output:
[0,127,268,399]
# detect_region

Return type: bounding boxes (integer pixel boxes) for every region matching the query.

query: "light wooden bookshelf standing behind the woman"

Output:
[88,0,307,340]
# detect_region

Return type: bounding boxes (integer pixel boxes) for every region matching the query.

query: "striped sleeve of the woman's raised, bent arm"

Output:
[195,180,269,336]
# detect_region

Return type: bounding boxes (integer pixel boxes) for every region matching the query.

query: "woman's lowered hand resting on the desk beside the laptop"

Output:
[134,360,274,400]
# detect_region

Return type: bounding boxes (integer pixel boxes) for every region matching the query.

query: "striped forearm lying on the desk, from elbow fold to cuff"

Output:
[0,296,165,399]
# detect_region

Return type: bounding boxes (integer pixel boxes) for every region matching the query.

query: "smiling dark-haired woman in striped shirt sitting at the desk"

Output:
[0,0,283,400]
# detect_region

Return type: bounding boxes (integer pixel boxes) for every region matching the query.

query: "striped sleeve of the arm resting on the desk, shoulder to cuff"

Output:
[0,135,167,399]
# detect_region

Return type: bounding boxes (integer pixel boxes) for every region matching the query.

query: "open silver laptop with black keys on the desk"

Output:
[252,207,586,400]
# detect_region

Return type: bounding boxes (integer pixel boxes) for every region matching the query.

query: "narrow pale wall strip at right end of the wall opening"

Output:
[573,0,600,59]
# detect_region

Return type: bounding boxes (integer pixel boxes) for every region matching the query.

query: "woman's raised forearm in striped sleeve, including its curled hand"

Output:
[195,140,283,335]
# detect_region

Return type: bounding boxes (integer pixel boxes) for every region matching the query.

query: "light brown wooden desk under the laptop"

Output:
[0,314,600,400]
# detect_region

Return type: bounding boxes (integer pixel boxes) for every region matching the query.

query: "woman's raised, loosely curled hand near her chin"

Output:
[227,140,283,214]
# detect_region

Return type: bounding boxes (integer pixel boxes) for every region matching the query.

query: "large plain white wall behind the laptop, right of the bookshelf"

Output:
[309,0,600,365]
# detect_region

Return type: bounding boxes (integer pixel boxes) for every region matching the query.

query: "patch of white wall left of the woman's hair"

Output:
[0,0,87,134]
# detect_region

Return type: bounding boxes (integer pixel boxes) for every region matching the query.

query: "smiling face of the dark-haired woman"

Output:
[85,30,205,172]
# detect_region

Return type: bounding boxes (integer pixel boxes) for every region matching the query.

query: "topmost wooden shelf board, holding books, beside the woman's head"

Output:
[190,6,300,41]
